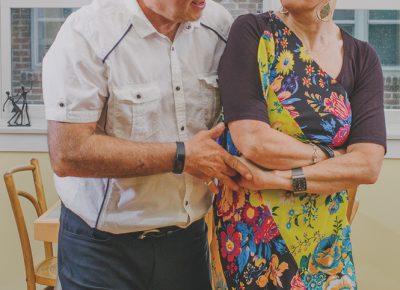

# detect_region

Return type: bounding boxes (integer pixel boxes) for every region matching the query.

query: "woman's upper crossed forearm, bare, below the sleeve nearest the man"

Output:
[229,120,339,170]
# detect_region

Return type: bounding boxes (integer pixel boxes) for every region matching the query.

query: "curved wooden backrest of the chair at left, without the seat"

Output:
[4,159,53,290]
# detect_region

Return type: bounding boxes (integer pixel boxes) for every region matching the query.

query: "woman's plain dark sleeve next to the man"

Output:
[218,14,268,123]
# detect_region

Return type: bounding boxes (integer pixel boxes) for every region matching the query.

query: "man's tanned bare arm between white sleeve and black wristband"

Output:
[48,121,176,177]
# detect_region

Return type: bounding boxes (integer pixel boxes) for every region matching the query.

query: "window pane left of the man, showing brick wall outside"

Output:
[5,8,74,108]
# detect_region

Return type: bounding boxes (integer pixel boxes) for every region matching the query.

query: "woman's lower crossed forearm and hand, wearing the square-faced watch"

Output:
[239,143,385,194]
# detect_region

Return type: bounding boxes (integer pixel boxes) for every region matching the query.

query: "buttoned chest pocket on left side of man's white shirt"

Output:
[113,83,161,142]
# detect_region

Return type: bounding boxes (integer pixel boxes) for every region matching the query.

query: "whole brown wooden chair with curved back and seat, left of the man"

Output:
[4,159,57,290]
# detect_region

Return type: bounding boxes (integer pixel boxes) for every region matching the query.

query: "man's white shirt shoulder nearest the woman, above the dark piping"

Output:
[200,0,233,37]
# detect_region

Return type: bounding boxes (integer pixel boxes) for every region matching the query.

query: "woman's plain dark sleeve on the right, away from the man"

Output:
[347,43,386,150]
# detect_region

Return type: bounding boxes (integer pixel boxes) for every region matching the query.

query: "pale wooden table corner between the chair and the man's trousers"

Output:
[33,201,61,243]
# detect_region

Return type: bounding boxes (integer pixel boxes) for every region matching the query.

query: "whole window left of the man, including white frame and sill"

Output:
[0,0,91,151]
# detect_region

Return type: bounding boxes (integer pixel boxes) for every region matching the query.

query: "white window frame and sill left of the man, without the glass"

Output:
[0,0,91,152]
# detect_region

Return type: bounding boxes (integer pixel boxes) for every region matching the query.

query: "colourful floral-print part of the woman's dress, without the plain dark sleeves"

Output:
[211,12,357,290]
